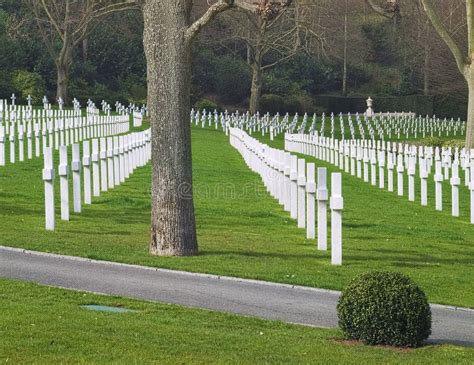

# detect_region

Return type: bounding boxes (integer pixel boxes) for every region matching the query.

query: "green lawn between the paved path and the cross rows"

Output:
[0,127,474,308]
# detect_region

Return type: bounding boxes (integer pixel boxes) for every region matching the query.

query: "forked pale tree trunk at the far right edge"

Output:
[421,0,474,149]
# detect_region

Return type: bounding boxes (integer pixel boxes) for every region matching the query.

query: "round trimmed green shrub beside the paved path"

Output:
[337,272,431,347]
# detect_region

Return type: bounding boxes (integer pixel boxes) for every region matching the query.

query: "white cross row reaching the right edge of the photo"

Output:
[285,134,474,224]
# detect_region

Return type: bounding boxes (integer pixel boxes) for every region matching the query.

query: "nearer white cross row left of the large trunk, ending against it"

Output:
[43,130,151,231]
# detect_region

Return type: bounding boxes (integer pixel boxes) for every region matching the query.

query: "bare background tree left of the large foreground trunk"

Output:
[27,0,138,101]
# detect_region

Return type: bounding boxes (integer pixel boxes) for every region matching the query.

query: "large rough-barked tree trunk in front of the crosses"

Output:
[144,0,198,256]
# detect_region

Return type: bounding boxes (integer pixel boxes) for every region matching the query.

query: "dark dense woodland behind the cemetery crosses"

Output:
[0,0,467,118]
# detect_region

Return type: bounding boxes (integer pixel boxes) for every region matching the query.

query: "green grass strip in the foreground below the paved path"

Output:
[0,280,474,364]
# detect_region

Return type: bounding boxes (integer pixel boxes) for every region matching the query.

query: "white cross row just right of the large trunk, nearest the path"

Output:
[229,128,343,265]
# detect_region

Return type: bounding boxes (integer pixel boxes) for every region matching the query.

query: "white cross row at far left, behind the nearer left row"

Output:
[0,107,130,166]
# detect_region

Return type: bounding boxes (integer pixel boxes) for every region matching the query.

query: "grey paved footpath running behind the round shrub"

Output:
[0,246,474,346]
